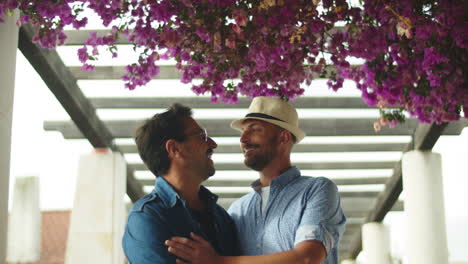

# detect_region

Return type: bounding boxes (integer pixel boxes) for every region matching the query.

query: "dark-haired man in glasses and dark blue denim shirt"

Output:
[122,104,237,264]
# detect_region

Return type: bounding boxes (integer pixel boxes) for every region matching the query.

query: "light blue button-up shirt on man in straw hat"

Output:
[228,167,346,264]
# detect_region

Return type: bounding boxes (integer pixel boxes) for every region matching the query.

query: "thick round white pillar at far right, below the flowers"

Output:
[402,151,448,264]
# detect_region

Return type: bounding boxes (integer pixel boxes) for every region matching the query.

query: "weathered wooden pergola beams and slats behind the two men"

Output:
[19,26,467,258]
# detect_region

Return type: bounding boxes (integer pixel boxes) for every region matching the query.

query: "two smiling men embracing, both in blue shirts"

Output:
[123,97,346,264]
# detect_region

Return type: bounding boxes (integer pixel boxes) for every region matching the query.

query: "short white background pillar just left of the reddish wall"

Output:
[7,177,41,263]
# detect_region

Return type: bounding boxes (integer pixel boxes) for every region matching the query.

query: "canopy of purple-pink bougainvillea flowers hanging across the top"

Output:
[0,0,468,125]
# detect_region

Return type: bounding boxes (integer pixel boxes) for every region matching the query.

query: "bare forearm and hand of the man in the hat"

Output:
[166,233,327,264]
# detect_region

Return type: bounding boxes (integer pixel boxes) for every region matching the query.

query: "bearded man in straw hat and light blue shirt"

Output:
[166,97,346,264]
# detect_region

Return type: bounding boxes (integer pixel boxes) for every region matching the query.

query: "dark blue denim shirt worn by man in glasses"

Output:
[122,177,238,264]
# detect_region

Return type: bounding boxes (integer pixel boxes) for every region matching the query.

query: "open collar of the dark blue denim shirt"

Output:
[152,176,218,207]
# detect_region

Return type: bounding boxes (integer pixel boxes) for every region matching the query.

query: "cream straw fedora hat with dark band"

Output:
[231,96,305,143]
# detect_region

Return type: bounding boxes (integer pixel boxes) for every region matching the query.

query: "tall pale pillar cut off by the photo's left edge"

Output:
[0,11,18,264]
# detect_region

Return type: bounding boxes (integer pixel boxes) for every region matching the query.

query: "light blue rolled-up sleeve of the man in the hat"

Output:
[294,178,346,254]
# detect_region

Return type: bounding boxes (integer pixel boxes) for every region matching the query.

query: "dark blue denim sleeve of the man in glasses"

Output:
[122,211,176,264]
